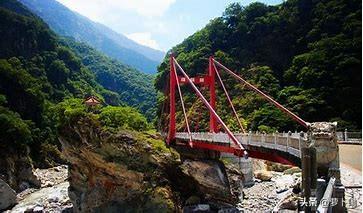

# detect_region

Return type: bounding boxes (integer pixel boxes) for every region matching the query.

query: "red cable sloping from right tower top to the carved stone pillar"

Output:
[213,59,308,128]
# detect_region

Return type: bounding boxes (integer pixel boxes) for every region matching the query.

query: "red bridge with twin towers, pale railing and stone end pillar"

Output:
[166,55,345,212]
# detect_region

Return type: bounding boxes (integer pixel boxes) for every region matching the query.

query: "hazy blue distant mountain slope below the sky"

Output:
[20,0,164,73]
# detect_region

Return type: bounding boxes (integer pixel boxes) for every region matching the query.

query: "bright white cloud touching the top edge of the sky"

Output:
[58,0,176,19]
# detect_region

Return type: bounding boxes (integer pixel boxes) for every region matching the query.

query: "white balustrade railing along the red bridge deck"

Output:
[176,132,307,158]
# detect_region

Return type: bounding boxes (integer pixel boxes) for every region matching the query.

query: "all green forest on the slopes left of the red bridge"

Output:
[0,0,151,169]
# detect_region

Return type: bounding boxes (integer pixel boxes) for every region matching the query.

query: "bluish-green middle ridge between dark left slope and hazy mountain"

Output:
[62,38,156,120]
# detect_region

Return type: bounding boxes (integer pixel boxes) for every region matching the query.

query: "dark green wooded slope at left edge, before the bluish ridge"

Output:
[0,0,148,167]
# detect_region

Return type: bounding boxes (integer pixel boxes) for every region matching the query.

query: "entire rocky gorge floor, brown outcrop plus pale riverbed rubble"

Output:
[1,117,361,213]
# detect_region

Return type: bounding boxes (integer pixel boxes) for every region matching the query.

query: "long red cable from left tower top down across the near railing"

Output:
[171,57,248,156]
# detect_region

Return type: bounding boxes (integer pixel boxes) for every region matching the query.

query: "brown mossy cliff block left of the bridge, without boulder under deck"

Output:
[60,119,182,212]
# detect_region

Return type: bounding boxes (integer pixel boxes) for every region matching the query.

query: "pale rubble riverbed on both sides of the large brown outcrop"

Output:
[6,153,362,213]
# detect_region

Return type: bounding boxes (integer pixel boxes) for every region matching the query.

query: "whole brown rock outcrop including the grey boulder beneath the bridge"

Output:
[60,118,237,212]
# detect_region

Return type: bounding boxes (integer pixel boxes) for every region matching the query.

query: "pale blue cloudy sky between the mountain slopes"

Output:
[57,0,282,51]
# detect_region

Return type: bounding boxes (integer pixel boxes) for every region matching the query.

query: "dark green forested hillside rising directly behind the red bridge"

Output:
[156,0,362,131]
